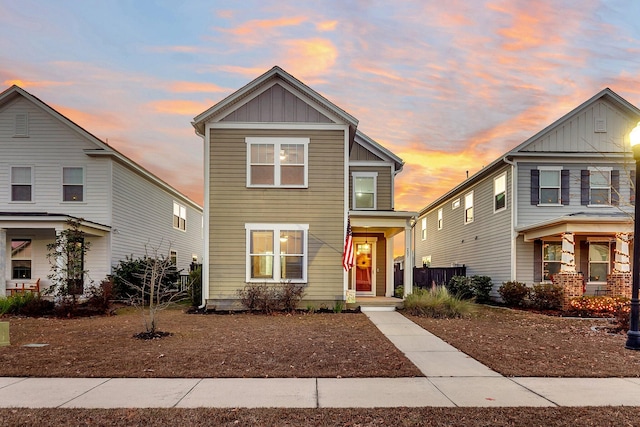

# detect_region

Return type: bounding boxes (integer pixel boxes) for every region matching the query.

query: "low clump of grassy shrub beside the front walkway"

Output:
[404,286,475,318]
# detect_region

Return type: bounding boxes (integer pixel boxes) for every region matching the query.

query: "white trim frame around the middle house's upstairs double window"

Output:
[245,136,311,188]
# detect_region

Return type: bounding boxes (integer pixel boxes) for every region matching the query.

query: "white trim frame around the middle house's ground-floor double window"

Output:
[244,223,309,283]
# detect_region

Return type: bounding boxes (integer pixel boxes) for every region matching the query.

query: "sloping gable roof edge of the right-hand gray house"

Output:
[418,88,640,216]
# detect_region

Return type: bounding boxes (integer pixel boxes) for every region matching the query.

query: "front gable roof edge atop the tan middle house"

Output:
[191,65,358,137]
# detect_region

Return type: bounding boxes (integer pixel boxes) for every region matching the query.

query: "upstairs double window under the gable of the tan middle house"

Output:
[246,138,309,188]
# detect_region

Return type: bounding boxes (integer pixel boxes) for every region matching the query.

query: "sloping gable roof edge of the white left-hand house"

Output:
[0,85,202,211]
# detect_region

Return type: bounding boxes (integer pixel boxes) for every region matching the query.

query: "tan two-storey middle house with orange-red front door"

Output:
[193,67,416,309]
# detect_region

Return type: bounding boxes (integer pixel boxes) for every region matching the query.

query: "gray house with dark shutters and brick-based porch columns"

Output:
[414,89,640,296]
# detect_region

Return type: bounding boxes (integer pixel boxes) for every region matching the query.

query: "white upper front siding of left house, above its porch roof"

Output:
[0,97,110,224]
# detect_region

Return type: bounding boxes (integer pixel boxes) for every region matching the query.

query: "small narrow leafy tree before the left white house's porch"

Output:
[47,218,91,313]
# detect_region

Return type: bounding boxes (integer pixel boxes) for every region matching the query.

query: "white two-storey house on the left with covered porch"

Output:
[0,86,203,295]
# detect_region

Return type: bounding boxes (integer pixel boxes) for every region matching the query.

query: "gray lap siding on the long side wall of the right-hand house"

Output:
[414,166,513,294]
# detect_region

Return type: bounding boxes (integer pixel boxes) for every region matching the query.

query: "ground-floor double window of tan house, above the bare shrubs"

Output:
[245,224,309,283]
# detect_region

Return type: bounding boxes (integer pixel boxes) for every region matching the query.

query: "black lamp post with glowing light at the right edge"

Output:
[625,122,640,350]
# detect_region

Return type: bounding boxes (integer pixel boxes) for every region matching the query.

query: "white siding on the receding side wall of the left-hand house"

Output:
[111,161,204,272]
